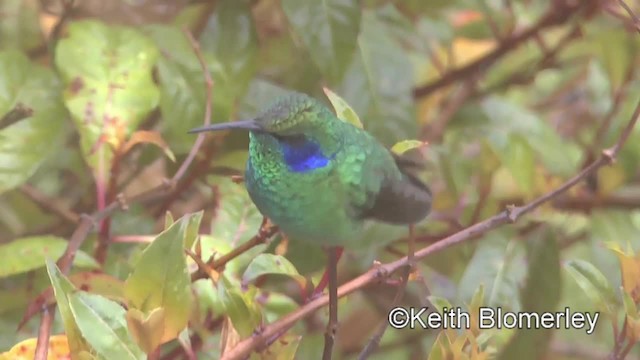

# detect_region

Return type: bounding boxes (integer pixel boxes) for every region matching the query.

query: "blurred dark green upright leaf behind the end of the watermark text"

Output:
[498,230,561,360]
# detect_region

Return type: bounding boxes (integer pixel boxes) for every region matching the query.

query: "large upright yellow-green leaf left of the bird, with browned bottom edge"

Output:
[124,213,202,343]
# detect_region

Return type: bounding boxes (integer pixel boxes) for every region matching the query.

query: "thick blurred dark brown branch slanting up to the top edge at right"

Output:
[413,1,597,98]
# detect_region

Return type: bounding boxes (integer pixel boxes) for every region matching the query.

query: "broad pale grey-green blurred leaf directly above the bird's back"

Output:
[335,10,417,145]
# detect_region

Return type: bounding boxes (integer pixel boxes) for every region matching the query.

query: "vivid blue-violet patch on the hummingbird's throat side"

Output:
[280,139,330,173]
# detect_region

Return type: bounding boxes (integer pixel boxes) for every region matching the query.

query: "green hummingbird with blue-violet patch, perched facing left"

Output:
[190,92,432,248]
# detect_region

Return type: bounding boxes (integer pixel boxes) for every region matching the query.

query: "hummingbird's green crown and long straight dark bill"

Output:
[189,92,331,137]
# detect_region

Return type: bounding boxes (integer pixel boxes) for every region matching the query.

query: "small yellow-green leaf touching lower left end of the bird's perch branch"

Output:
[218,273,262,338]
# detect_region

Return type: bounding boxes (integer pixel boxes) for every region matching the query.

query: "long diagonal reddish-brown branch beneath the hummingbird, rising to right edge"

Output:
[222,93,640,360]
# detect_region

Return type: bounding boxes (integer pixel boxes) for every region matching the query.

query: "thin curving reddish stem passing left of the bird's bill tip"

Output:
[35,31,213,360]
